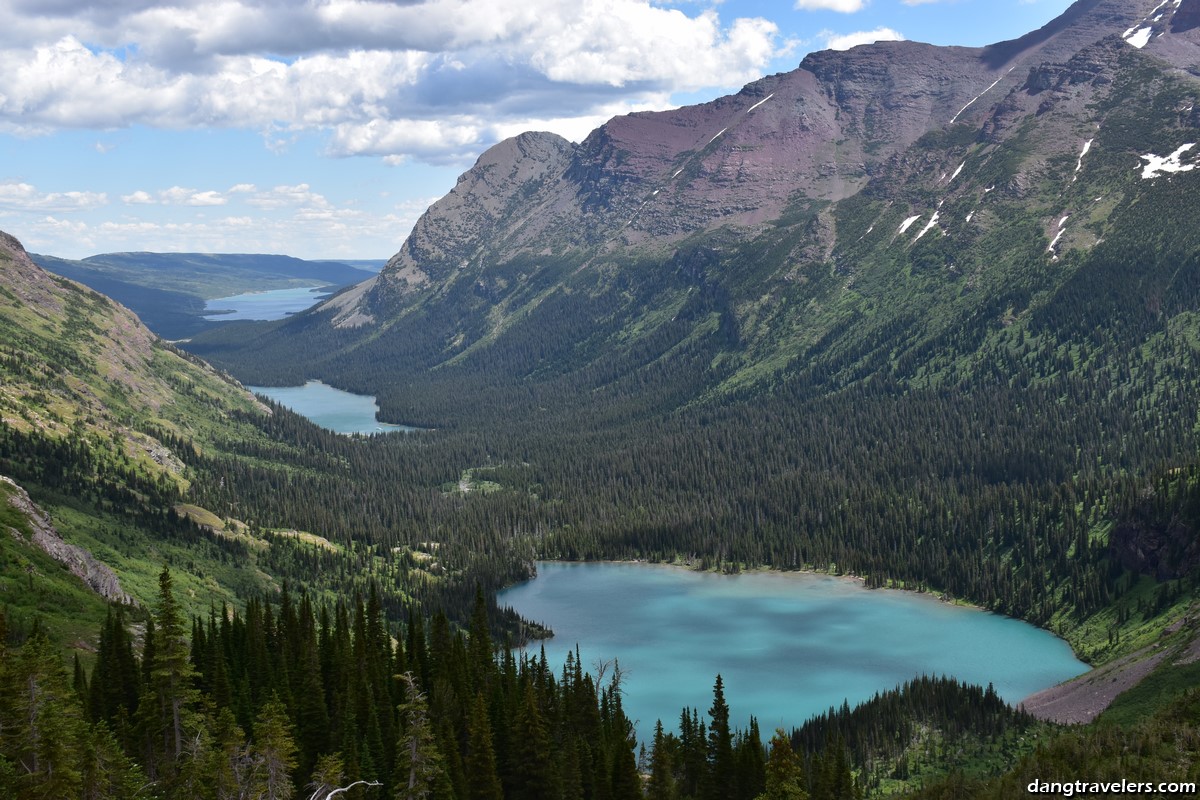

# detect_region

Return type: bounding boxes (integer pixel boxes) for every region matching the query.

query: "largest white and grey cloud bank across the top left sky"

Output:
[0,0,787,164]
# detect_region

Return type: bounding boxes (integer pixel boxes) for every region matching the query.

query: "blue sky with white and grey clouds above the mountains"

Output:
[0,0,1070,259]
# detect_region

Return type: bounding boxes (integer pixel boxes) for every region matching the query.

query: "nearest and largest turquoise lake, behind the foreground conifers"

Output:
[499,561,1088,741]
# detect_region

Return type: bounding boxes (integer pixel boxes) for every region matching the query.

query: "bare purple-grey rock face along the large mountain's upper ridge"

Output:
[325,0,1161,326]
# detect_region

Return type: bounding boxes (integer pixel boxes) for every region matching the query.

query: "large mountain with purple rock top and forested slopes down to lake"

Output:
[188,0,1200,642]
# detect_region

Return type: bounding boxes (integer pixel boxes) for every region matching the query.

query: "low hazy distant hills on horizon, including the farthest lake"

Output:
[30,253,382,339]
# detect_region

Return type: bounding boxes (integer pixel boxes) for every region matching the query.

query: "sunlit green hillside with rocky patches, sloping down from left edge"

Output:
[0,227,524,662]
